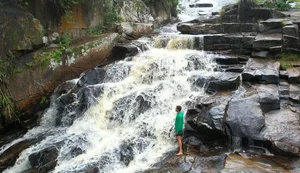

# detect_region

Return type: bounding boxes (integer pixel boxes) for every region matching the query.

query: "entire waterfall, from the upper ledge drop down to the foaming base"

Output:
[0,0,246,173]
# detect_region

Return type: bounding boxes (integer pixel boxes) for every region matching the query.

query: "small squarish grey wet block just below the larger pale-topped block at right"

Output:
[257,85,280,113]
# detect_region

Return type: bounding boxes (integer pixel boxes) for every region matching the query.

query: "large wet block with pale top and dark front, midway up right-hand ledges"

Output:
[242,59,280,84]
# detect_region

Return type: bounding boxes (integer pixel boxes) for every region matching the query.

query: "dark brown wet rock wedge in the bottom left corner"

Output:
[0,139,39,172]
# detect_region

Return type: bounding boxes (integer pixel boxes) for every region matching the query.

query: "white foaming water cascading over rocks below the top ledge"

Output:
[2,48,220,173]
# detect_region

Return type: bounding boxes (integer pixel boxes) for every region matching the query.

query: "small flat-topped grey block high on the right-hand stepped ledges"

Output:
[252,33,282,50]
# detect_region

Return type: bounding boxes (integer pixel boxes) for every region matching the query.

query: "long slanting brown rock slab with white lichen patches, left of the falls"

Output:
[2,34,118,125]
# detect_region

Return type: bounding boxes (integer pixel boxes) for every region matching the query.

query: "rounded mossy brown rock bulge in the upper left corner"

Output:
[0,1,43,60]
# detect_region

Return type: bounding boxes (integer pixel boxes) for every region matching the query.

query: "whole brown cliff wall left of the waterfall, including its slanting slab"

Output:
[0,0,177,126]
